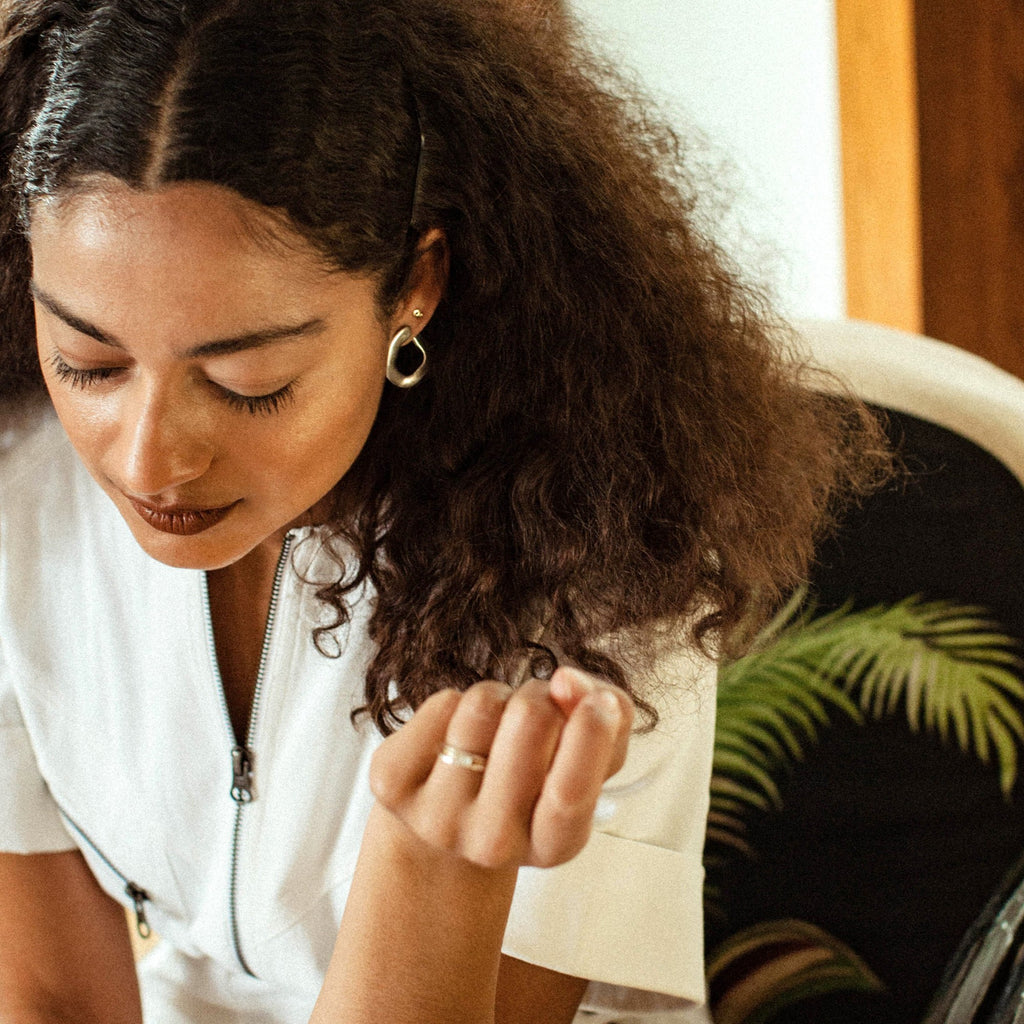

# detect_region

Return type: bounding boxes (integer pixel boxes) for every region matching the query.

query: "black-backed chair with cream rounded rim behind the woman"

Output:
[704,321,1024,1024]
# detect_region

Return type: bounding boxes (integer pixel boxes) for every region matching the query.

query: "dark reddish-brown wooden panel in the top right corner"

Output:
[915,0,1024,376]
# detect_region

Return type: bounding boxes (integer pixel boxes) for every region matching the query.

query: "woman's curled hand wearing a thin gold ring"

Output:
[371,668,633,868]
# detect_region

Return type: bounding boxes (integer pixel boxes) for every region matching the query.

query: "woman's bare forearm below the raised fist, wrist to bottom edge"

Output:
[311,805,516,1024]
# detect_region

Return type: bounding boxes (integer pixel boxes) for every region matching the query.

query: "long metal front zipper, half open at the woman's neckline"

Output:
[203,531,292,978]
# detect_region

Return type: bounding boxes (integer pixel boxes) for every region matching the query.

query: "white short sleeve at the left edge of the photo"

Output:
[0,646,75,853]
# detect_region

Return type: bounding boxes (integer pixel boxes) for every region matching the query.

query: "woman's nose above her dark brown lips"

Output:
[111,384,213,498]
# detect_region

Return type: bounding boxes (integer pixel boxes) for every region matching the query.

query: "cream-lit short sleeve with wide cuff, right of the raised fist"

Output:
[504,651,715,1006]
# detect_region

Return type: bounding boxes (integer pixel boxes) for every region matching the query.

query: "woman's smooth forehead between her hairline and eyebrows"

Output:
[31,183,374,337]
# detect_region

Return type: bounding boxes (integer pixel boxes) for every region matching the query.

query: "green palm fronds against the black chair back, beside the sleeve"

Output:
[711,590,1024,876]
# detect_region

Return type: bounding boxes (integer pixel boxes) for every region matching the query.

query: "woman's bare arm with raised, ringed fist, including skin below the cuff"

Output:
[312,669,633,1024]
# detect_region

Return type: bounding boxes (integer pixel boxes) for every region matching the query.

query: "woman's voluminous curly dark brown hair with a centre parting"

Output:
[0,0,881,732]
